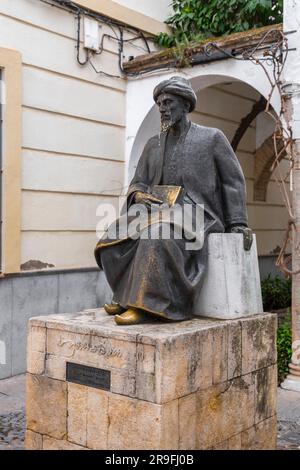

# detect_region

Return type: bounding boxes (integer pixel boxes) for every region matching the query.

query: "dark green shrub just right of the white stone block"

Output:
[261,274,292,312]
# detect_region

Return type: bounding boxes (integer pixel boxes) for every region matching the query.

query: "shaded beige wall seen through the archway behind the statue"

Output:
[192,83,289,255]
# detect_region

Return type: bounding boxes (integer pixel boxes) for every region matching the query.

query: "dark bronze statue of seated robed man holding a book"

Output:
[95,76,252,325]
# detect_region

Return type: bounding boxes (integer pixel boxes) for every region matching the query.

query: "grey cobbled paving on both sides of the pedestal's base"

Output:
[0,375,300,450]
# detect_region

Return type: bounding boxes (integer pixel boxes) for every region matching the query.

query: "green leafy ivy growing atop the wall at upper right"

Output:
[157,0,283,47]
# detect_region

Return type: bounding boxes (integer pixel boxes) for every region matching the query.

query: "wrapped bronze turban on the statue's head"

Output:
[153,77,197,113]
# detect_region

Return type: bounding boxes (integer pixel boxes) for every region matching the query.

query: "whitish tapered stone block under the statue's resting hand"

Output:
[194,233,263,320]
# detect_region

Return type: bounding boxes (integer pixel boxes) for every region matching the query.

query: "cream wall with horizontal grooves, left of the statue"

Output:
[0,0,162,271]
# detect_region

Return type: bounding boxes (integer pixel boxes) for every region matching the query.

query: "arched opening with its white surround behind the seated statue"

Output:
[126,64,289,276]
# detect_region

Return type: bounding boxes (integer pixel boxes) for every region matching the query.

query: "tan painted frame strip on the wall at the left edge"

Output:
[0,47,22,272]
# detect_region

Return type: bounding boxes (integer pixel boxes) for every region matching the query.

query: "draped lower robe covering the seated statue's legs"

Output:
[101,223,200,324]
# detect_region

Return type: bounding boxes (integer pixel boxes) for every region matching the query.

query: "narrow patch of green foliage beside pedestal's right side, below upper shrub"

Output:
[277,320,292,384]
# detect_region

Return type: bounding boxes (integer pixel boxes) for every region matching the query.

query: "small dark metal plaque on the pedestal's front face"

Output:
[66,362,110,390]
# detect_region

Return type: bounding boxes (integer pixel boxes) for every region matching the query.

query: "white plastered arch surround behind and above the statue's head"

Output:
[125,59,280,185]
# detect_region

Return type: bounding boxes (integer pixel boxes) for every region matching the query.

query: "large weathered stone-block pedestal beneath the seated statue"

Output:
[26,309,277,450]
